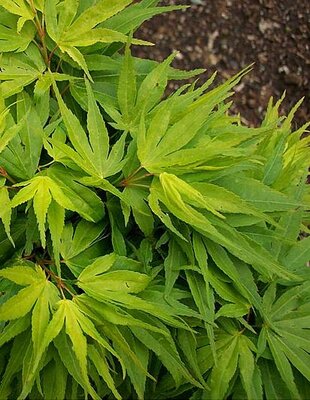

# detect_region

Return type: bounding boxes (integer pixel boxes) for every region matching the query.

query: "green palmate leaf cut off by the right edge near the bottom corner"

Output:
[260,281,310,398]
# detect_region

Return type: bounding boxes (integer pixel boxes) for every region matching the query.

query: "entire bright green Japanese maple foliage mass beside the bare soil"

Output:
[0,0,310,400]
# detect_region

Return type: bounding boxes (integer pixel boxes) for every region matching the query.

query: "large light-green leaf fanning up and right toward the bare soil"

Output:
[137,66,249,173]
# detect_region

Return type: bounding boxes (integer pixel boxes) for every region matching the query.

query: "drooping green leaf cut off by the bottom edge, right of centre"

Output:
[158,328,263,399]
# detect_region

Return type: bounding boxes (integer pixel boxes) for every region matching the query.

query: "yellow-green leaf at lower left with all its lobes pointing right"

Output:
[78,253,198,329]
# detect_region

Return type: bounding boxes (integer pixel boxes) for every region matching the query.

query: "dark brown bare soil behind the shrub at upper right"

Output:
[135,0,310,127]
